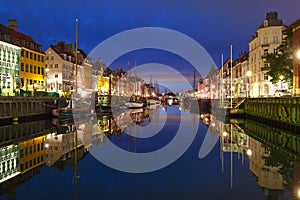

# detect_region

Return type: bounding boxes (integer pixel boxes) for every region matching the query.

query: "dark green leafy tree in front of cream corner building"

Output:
[266,27,293,87]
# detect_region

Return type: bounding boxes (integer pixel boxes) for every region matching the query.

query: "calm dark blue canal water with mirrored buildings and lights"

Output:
[0,105,300,200]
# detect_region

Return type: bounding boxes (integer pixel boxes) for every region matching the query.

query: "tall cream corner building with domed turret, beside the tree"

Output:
[249,12,286,97]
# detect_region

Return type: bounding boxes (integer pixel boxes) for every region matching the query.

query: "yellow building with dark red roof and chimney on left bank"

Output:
[1,20,45,91]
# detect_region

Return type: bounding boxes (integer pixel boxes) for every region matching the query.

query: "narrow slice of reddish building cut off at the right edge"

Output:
[290,19,300,96]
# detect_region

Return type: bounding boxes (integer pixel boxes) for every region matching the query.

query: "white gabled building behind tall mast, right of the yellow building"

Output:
[45,42,92,95]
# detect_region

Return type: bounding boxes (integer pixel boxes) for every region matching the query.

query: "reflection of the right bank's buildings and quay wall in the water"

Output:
[209,114,300,199]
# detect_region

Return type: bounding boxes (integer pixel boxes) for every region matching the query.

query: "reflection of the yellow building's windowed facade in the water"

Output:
[19,136,45,173]
